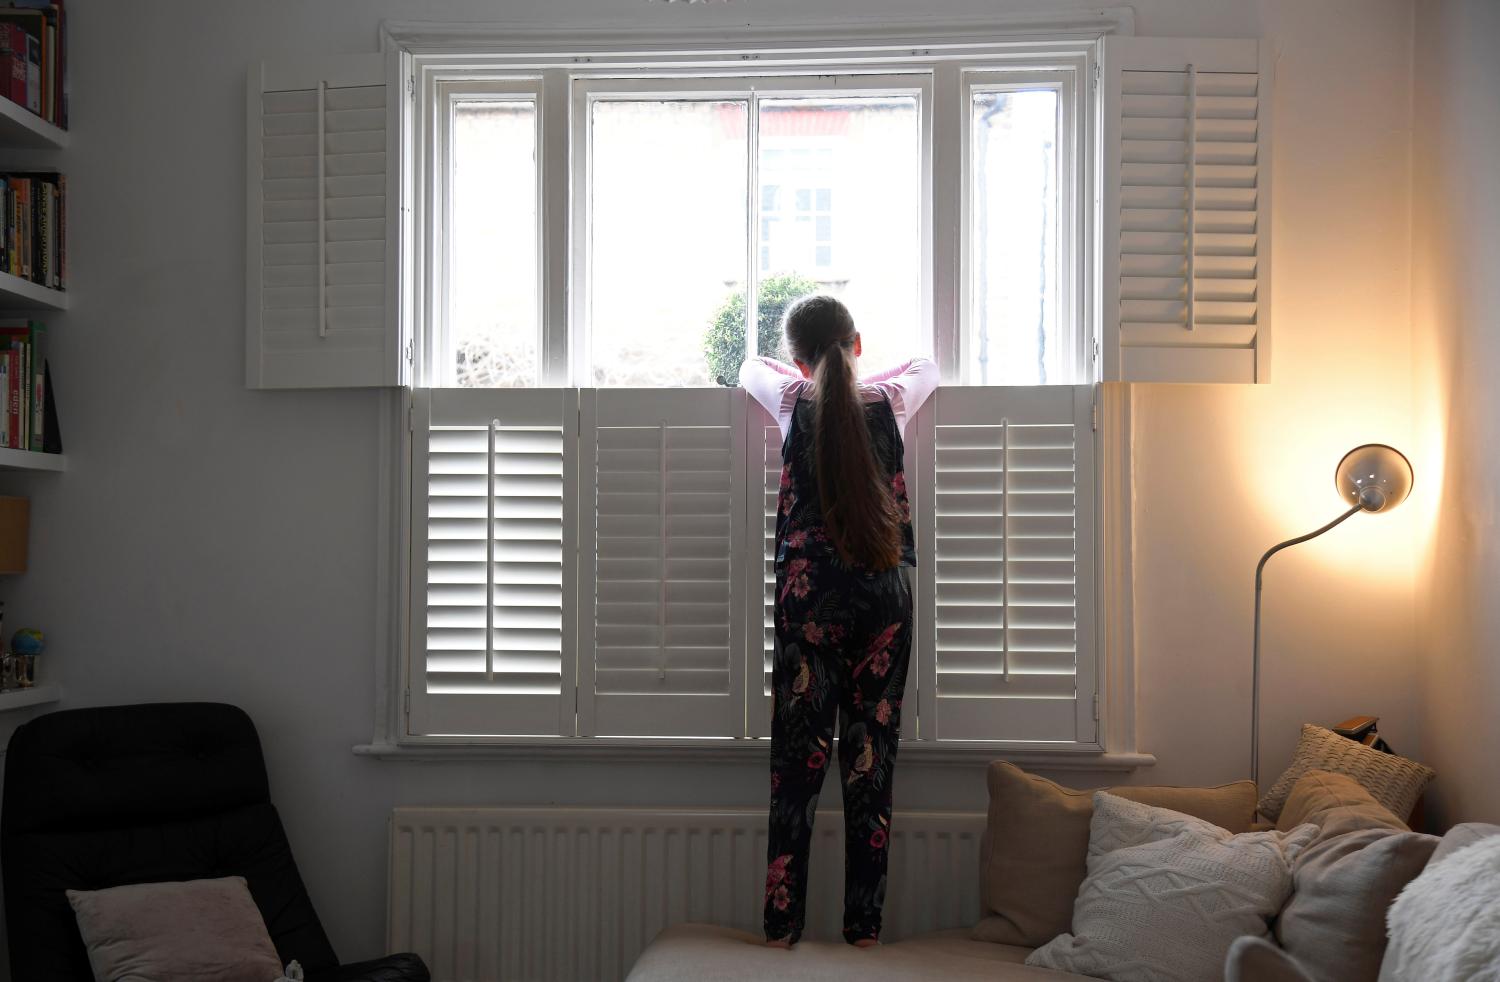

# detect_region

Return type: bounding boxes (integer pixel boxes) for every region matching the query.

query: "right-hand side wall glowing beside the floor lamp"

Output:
[1412,0,1500,822]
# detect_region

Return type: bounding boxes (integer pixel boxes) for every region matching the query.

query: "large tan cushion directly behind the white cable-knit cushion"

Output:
[972,760,1256,948]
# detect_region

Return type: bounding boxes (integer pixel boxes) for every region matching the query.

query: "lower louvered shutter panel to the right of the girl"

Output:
[918,385,1097,744]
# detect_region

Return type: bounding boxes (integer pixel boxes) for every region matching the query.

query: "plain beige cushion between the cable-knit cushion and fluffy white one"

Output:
[1277,827,1437,982]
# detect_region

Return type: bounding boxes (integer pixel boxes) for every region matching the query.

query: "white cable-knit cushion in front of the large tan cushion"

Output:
[1026,792,1317,982]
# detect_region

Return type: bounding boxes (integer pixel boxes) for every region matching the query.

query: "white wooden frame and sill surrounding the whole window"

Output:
[369,26,1154,771]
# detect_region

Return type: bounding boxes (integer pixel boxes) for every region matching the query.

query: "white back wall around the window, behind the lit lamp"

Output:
[0,0,1416,958]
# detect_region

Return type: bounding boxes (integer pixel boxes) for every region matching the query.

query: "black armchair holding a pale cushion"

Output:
[0,703,429,982]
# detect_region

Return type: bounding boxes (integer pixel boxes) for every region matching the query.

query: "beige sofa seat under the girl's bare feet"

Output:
[626,924,1073,982]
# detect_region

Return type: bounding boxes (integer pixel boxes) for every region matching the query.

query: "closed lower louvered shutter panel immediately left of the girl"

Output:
[579,388,753,736]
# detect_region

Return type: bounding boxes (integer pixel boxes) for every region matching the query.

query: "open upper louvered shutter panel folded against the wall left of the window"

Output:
[246,54,401,388]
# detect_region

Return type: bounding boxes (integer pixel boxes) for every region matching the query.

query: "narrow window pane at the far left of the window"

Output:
[450,99,540,387]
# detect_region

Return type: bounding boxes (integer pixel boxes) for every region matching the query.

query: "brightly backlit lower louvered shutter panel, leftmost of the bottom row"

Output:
[408,388,578,736]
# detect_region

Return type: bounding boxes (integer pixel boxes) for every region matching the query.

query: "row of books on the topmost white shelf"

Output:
[0,0,68,129]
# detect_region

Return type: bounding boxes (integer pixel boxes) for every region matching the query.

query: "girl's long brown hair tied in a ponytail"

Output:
[785,295,902,570]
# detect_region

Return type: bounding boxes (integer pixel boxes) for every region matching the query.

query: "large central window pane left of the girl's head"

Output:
[588,100,749,385]
